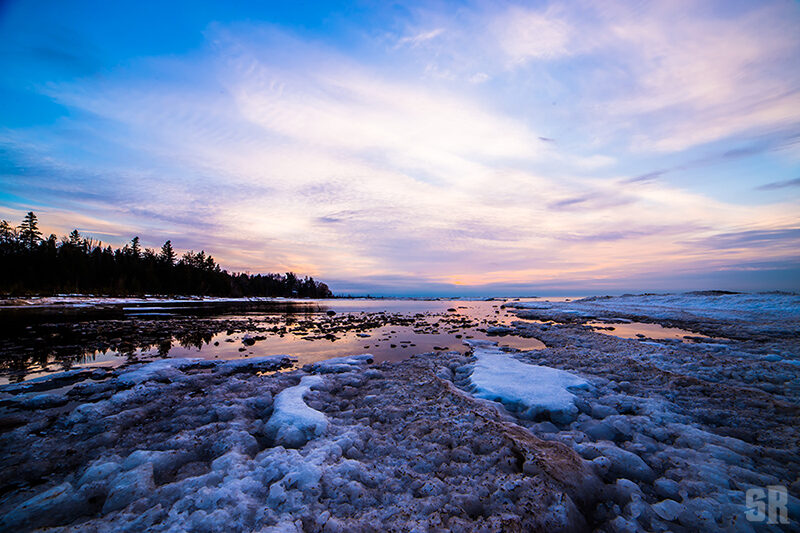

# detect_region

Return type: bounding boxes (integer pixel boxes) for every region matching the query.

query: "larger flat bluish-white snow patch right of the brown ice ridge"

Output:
[468,341,589,423]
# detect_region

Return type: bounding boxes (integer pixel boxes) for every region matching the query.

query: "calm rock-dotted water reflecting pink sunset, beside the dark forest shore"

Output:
[0,299,545,384]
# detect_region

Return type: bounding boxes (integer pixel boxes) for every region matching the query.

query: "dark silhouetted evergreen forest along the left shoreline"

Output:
[0,212,332,298]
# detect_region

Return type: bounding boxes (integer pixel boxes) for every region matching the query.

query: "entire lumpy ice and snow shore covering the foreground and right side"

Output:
[0,295,800,531]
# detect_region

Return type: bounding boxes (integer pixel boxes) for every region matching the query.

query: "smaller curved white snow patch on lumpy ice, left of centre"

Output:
[265,376,328,448]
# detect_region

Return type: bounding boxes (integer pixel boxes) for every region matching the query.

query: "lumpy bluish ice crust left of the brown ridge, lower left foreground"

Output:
[0,344,592,532]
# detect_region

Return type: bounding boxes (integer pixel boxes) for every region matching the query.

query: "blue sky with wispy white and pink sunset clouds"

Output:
[0,0,800,295]
